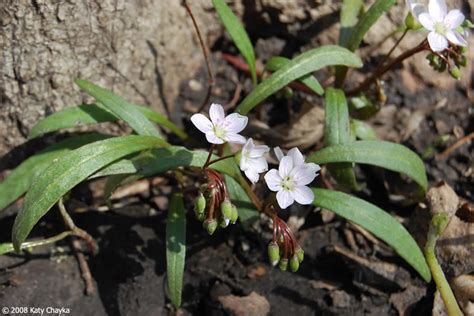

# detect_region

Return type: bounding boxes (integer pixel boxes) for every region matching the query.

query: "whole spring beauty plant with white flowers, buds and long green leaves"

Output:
[0,0,472,308]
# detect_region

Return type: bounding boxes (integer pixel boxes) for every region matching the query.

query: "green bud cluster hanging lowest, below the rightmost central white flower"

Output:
[268,216,304,272]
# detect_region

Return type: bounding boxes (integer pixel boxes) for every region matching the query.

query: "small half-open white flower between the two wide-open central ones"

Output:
[240,138,270,183]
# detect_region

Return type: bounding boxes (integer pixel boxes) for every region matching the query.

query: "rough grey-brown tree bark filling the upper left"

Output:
[0,0,222,157]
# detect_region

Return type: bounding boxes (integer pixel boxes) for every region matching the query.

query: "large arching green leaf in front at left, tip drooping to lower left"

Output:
[12,135,166,250]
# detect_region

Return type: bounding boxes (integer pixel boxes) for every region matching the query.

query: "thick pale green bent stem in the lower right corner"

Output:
[425,213,462,316]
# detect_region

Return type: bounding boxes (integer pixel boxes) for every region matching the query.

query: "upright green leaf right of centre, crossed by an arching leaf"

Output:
[324,88,359,190]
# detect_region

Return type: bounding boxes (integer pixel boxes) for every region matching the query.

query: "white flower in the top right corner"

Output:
[414,0,467,52]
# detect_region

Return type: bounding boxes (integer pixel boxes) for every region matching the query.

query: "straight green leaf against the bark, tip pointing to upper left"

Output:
[76,79,161,138]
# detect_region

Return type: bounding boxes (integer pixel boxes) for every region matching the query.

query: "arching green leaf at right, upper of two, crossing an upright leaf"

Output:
[308,140,428,191]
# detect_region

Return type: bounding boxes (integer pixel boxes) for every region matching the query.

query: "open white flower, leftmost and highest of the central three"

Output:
[191,103,248,144]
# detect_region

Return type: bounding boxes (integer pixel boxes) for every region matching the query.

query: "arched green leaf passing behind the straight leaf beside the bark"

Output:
[28,101,188,140]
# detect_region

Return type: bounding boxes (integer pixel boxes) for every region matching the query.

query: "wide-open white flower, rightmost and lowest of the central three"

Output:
[265,147,320,209]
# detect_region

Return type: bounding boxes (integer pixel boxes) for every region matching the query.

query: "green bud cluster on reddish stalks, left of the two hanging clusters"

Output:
[194,169,239,235]
